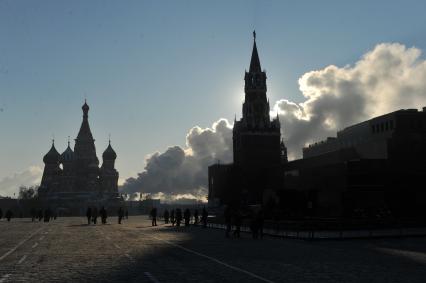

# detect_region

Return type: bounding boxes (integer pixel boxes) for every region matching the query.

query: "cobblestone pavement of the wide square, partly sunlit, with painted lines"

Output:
[0,216,426,283]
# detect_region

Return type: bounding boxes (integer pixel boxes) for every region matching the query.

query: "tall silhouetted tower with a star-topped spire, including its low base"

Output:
[209,33,287,204]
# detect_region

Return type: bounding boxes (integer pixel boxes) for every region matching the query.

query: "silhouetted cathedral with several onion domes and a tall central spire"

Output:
[38,102,122,214]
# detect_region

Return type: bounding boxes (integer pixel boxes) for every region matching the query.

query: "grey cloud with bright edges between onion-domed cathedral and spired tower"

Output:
[121,119,232,200]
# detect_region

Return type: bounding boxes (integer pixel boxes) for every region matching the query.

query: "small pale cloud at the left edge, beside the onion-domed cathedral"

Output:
[0,166,43,196]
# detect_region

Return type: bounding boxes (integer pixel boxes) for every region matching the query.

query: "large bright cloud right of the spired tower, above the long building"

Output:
[273,43,426,158]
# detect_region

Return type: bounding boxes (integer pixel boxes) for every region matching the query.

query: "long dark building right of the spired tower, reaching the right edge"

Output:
[280,107,426,217]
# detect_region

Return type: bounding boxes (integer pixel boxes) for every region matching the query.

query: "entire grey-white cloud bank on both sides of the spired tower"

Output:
[121,43,426,199]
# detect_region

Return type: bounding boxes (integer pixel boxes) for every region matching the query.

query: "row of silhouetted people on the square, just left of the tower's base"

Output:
[150,207,209,227]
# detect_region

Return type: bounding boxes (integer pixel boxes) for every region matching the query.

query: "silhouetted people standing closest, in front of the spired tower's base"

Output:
[224,206,265,239]
